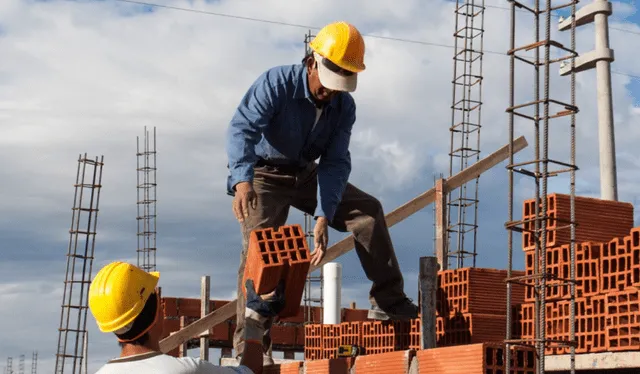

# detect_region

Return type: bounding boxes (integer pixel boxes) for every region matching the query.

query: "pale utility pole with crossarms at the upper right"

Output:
[558,0,618,201]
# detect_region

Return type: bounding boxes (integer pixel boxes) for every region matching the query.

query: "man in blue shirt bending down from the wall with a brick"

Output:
[227,22,418,359]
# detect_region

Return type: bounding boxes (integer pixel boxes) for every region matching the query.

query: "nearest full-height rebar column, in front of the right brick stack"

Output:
[505,0,577,374]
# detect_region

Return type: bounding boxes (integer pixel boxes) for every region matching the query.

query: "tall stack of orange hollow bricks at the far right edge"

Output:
[514,194,640,354]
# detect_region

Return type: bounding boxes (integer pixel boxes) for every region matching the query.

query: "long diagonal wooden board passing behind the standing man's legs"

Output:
[160,136,528,353]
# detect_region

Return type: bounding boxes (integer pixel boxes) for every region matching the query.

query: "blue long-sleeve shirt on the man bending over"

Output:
[227,64,356,222]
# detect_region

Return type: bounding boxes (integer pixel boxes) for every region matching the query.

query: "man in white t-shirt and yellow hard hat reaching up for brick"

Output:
[89,261,284,374]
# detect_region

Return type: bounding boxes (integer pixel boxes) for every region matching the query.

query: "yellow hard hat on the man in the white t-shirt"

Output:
[89,261,160,333]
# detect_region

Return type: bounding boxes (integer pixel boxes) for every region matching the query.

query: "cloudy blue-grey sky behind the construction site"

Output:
[0,0,640,372]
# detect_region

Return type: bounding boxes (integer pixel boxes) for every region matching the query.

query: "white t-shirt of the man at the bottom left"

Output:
[96,352,254,374]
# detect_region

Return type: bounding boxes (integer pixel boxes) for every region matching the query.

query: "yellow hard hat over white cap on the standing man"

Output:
[309,21,365,91]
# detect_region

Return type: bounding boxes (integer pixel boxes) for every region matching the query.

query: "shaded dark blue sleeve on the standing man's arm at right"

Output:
[315,103,356,222]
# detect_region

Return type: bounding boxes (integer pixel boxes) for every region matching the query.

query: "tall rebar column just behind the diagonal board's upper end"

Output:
[446,0,485,268]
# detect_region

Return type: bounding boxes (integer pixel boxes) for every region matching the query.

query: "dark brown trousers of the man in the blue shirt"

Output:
[233,163,405,355]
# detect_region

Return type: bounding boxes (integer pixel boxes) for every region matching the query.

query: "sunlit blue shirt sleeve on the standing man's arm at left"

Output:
[226,73,278,195]
